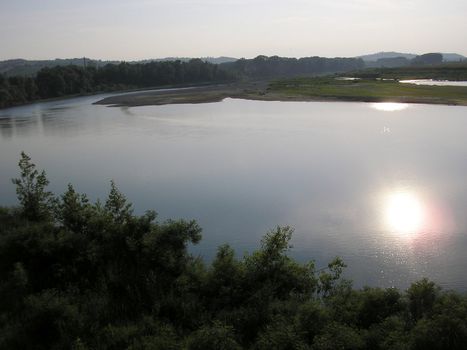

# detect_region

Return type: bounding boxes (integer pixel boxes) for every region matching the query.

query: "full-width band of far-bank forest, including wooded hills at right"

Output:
[0,54,467,108]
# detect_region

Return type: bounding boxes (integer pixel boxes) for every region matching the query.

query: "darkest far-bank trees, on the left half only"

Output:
[0,59,233,108]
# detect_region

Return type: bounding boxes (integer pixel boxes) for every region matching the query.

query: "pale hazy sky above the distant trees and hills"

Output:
[0,0,467,60]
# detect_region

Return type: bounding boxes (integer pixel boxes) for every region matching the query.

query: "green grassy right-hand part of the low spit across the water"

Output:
[268,77,467,105]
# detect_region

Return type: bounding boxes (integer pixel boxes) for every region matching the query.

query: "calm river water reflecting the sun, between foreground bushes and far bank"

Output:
[0,96,467,290]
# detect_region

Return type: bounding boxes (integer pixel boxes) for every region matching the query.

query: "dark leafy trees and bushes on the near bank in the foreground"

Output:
[0,153,467,350]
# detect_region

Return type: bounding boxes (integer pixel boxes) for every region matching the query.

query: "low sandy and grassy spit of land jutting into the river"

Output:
[96,77,467,107]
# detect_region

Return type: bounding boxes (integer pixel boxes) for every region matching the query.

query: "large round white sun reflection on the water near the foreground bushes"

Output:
[385,192,425,234]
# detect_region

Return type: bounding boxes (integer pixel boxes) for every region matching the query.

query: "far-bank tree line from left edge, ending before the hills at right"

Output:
[0,56,372,108]
